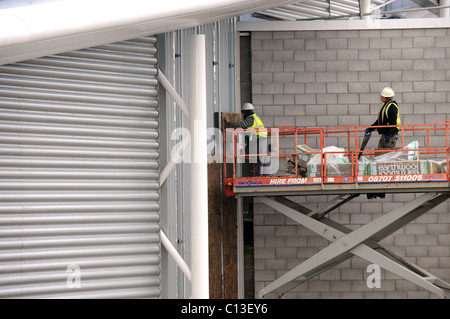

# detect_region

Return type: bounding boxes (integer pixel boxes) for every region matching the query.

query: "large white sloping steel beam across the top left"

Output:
[0,0,302,65]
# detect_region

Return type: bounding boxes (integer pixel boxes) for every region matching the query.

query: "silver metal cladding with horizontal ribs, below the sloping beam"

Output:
[0,37,160,298]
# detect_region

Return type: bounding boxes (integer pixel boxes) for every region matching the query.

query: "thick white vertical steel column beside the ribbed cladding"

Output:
[189,34,209,299]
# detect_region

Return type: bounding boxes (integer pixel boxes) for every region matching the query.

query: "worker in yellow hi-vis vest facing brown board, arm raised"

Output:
[224,103,268,176]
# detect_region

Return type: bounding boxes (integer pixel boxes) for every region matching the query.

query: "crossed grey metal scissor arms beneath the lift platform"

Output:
[258,192,450,298]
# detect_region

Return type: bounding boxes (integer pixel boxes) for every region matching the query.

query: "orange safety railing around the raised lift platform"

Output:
[223,121,450,195]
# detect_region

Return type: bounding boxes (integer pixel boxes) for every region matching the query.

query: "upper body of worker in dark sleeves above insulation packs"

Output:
[365,87,400,148]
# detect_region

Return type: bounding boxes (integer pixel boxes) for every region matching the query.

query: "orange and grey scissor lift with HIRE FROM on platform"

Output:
[224,122,450,298]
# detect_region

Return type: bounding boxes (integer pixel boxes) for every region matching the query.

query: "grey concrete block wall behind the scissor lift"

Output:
[251,29,450,298]
